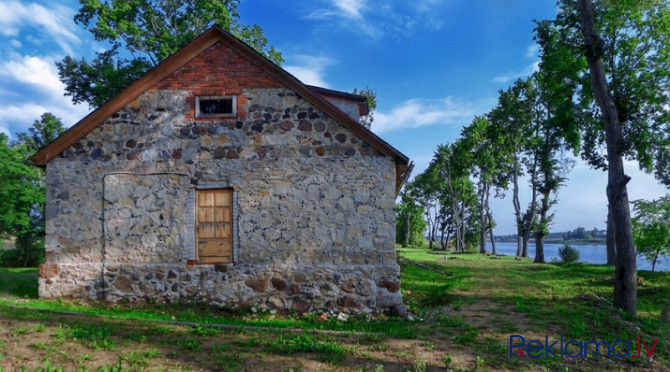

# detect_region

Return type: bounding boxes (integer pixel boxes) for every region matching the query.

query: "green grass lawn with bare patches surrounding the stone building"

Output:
[0,249,670,371]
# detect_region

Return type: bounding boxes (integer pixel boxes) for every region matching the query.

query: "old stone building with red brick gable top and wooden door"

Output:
[31,26,411,312]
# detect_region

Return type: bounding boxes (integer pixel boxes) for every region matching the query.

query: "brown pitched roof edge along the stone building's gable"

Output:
[30,25,409,190]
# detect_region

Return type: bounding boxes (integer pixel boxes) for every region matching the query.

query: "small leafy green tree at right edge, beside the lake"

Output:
[633,195,670,271]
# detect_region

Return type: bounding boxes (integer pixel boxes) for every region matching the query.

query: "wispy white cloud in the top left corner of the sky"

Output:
[0,0,80,54]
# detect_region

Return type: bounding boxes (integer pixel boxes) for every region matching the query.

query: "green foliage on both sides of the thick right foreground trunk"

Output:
[535,0,670,185]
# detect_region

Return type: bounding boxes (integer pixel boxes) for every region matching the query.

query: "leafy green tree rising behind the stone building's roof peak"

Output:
[56,0,283,107]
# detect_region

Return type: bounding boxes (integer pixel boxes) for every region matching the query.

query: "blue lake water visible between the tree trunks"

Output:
[488,242,670,271]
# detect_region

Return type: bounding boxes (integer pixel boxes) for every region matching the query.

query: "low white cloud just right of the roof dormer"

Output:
[372,97,494,133]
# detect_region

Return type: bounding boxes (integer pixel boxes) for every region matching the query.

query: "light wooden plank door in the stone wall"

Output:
[195,189,233,263]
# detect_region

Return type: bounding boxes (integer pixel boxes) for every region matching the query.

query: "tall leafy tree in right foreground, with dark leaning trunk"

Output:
[536,0,670,315]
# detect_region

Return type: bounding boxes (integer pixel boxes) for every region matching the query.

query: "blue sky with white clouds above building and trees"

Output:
[0,0,670,234]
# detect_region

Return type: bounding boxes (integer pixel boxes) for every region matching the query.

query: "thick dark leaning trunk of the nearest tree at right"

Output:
[577,0,637,316]
